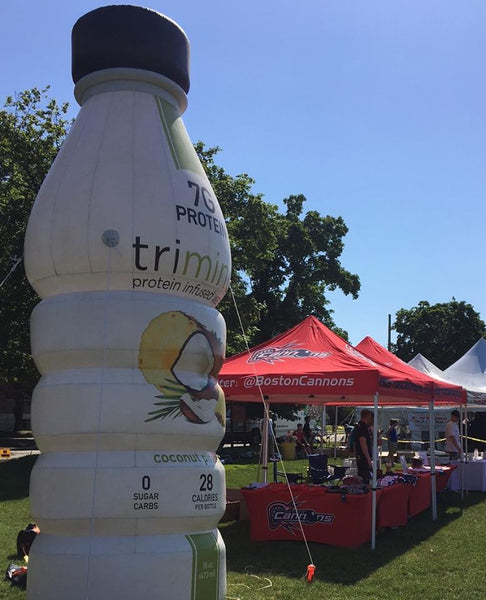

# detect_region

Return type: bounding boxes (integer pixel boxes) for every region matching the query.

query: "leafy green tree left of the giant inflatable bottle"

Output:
[0,87,69,426]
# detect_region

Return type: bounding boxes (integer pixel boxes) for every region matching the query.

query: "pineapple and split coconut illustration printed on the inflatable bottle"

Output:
[138,311,225,425]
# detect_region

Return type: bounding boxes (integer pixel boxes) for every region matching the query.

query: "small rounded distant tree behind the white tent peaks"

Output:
[393,298,486,369]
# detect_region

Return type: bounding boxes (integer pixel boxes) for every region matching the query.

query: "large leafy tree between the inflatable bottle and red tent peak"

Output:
[196,142,360,353]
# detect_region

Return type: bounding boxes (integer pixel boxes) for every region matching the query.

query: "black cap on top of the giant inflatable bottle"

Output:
[71,4,190,93]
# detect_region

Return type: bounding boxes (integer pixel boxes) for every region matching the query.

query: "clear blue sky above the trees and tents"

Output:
[0,0,486,344]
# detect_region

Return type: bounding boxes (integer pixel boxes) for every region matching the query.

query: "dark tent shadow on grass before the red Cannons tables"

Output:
[220,492,486,585]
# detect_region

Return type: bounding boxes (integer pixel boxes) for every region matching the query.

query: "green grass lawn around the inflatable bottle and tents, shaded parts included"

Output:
[0,457,486,600]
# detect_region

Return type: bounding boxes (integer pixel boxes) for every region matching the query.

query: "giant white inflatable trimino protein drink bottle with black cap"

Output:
[25,5,231,600]
